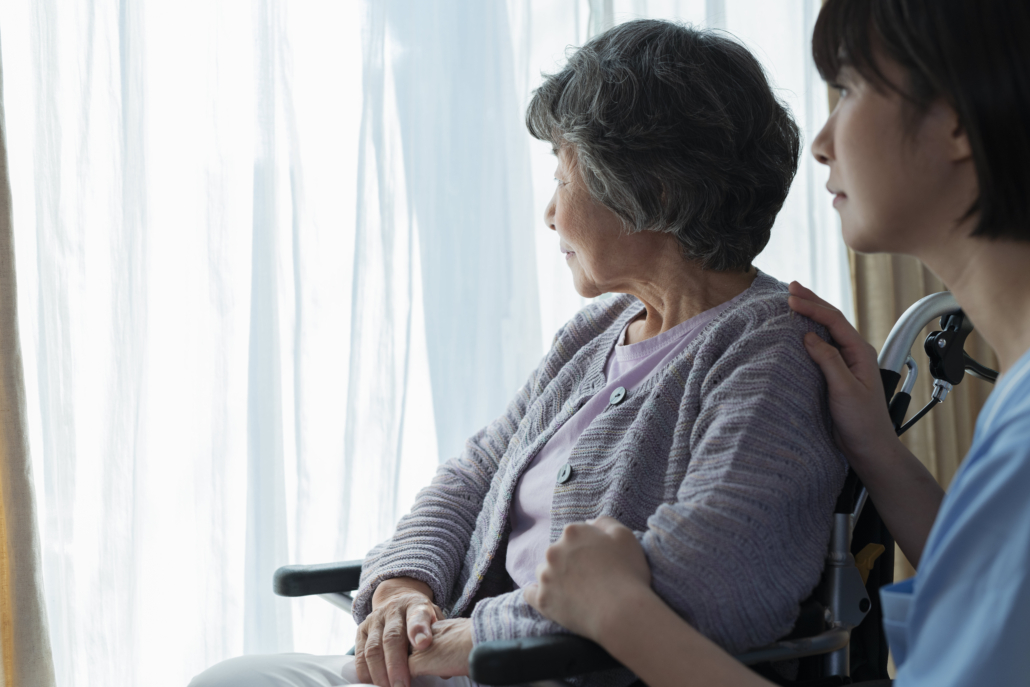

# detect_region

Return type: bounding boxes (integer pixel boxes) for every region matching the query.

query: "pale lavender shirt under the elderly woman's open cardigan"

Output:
[505,294,743,587]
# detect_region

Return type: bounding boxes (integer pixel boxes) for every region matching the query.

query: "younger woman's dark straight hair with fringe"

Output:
[812,0,1030,240]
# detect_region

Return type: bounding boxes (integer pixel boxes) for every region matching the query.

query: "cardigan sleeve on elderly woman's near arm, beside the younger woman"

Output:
[640,307,847,652]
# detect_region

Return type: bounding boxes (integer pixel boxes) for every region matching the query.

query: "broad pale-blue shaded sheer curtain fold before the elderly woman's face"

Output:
[381,0,553,460]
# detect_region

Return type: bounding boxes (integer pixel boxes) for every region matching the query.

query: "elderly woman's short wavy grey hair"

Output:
[525,20,800,271]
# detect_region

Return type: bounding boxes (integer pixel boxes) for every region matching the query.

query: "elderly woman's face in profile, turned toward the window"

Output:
[544,147,671,298]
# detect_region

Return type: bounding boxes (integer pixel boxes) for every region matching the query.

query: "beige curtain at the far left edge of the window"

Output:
[0,41,55,687]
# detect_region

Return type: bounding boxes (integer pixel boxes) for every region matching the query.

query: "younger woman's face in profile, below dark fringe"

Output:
[812,61,975,254]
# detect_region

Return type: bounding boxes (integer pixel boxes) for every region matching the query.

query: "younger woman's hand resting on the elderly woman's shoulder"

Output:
[788,281,898,466]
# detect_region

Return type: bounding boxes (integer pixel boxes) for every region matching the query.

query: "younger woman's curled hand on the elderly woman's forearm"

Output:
[522,517,651,641]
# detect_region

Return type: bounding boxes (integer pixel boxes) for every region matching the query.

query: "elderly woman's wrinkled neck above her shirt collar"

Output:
[626,266,758,343]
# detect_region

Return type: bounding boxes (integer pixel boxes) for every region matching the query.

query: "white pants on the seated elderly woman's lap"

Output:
[190,654,475,687]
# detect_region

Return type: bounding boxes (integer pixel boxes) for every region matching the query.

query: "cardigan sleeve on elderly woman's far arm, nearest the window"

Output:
[353,344,549,623]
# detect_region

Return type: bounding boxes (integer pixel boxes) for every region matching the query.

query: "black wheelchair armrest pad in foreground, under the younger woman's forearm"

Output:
[469,634,621,685]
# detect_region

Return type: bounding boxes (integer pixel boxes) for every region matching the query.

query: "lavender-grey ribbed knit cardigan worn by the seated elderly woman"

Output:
[354,273,847,651]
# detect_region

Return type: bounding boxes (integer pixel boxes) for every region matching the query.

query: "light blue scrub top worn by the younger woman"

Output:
[880,351,1030,687]
